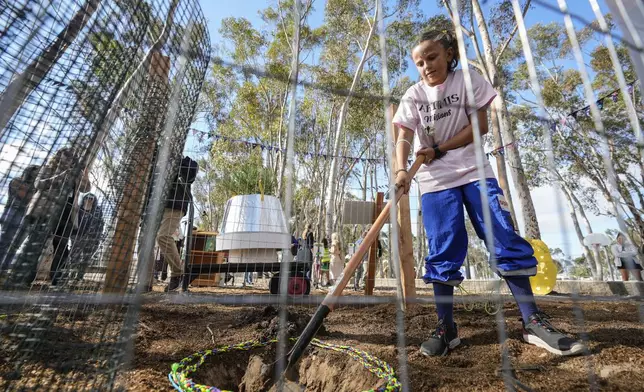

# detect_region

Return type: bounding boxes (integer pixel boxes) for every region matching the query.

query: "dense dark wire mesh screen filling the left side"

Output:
[0,0,210,390]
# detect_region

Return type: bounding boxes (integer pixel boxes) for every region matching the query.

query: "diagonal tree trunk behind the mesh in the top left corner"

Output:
[0,0,102,140]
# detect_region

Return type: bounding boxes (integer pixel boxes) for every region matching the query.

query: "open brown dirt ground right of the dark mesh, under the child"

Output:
[119,290,644,391]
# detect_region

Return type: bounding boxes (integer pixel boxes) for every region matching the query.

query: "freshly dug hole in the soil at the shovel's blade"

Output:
[192,349,386,392]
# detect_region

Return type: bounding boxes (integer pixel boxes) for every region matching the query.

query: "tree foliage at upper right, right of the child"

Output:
[512,18,644,242]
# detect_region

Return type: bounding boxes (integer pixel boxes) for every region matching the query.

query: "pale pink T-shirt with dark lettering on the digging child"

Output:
[393,70,496,194]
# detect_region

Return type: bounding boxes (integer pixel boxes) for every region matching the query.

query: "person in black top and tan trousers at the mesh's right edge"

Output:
[150,157,199,292]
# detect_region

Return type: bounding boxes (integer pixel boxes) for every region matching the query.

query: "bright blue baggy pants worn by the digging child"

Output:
[422,178,537,286]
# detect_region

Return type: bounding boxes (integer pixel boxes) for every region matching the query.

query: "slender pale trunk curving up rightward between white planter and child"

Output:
[326,7,378,238]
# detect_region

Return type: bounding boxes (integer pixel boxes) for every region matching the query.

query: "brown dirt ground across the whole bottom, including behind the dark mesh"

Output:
[0,287,644,392]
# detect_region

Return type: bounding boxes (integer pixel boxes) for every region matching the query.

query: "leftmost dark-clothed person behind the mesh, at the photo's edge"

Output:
[0,166,40,271]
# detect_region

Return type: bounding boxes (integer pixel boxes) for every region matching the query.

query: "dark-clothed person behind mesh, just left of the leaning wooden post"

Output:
[69,193,104,280]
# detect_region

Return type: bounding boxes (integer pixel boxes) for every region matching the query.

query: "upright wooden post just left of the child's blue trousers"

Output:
[389,104,420,306]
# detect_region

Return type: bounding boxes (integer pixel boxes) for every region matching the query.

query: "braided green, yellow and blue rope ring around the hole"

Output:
[168,338,402,392]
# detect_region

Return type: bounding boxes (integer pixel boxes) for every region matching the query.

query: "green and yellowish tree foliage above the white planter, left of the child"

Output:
[196,0,419,234]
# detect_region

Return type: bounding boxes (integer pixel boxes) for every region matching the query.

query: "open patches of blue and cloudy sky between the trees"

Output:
[192,0,628,257]
